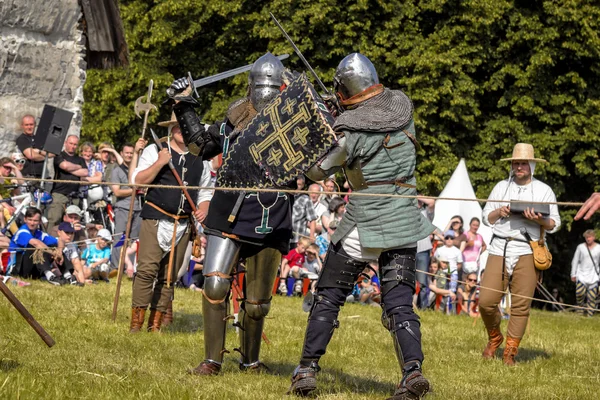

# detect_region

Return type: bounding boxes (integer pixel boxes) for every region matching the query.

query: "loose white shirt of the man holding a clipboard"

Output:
[483,178,560,260]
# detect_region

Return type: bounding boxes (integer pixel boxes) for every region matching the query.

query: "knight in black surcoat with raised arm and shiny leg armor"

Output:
[166,53,292,375]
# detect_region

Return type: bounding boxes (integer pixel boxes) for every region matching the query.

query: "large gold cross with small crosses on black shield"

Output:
[249,97,311,172]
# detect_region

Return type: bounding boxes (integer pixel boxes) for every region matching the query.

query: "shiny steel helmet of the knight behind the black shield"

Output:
[248,52,284,111]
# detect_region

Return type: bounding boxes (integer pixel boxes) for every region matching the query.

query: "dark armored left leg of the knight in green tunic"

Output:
[300,243,368,366]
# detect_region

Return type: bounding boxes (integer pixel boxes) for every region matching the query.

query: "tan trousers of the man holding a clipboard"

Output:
[479,254,539,339]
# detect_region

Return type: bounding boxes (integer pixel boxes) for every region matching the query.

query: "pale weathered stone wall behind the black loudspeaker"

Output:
[0,0,85,156]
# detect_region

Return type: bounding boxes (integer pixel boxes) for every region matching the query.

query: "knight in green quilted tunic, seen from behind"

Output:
[289,53,434,400]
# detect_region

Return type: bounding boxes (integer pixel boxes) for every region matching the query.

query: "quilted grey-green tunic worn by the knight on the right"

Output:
[331,120,435,249]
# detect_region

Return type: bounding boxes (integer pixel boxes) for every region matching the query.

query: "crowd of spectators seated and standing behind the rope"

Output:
[0,115,600,317]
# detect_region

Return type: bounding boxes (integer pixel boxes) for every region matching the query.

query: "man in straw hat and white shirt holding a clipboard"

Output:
[479,143,560,365]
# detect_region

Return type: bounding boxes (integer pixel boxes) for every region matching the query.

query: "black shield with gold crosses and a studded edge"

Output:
[218,74,335,188]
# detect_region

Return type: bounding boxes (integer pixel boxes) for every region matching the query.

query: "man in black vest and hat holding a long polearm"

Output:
[129,114,211,333]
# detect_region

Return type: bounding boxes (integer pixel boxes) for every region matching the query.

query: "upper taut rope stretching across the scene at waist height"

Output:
[4,178,584,207]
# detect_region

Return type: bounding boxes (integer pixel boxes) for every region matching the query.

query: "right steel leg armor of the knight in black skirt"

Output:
[238,248,281,367]
